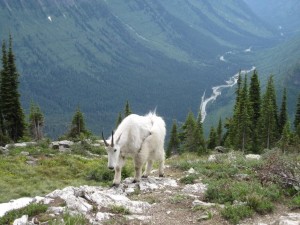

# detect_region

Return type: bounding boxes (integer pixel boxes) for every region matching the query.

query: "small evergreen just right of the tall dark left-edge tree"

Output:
[29,103,44,140]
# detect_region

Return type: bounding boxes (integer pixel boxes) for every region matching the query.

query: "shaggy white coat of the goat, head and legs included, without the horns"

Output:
[106,112,166,186]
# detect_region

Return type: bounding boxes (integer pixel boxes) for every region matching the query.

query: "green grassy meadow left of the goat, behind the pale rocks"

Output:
[0,154,109,202]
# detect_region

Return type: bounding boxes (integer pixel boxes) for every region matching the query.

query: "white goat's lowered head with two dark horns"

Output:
[102,132,120,170]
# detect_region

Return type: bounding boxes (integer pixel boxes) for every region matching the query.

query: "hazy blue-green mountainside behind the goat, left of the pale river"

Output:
[0,0,273,136]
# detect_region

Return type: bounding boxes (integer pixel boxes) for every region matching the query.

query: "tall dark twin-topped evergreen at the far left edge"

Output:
[0,35,26,141]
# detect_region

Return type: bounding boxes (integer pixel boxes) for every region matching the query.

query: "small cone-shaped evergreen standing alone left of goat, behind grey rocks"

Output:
[67,107,90,138]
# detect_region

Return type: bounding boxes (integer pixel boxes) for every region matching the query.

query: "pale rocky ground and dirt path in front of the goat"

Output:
[0,164,300,225]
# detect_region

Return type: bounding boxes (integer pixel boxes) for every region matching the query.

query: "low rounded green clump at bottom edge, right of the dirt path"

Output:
[221,205,254,224]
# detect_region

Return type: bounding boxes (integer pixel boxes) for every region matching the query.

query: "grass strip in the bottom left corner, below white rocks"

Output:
[0,204,48,224]
